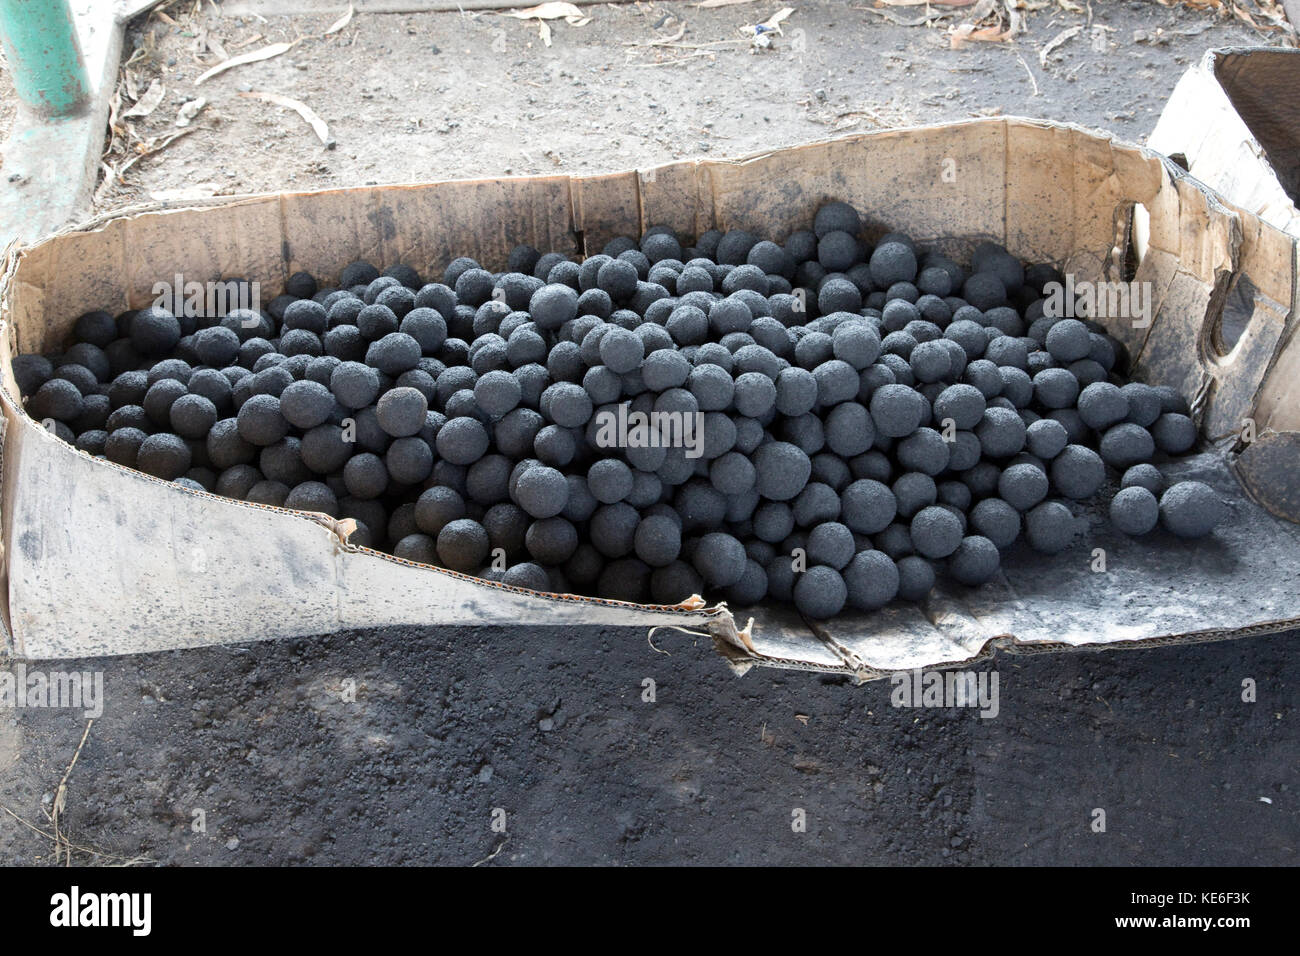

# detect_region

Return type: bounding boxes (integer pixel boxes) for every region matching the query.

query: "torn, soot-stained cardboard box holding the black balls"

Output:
[0,118,1300,680]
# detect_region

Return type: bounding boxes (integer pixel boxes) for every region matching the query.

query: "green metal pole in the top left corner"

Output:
[0,0,90,117]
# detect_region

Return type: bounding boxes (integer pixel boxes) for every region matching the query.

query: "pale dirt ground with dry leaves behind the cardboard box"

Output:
[100,0,1277,208]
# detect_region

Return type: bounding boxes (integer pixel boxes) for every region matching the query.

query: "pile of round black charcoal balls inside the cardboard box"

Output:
[13,202,1225,619]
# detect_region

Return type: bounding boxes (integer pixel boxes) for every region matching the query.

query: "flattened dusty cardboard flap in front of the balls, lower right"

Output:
[736,451,1300,678]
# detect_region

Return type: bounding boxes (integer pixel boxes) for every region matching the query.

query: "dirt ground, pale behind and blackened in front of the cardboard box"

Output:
[0,0,1300,865]
